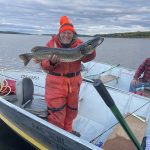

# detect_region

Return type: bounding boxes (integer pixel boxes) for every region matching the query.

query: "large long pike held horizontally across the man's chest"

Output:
[19,35,104,66]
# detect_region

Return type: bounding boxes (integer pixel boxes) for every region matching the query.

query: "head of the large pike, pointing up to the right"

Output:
[80,34,104,55]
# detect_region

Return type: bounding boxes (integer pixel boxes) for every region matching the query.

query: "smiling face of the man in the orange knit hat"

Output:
[60,30,74,44]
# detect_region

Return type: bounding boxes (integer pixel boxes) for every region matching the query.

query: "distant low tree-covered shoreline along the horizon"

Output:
[0,31,150,38]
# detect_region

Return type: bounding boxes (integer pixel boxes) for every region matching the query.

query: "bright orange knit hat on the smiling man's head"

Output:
[59,16,76,33]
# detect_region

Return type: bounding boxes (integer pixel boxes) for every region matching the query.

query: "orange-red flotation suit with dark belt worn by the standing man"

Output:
[41,36,96,132]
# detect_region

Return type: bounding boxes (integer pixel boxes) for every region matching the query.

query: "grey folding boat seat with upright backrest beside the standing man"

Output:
[16,78,47,118]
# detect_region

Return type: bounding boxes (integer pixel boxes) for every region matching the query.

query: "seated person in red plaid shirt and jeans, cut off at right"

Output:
[129,58,150,93]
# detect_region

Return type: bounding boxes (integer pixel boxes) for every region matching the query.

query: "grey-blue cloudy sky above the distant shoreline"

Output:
[0,0,150,35]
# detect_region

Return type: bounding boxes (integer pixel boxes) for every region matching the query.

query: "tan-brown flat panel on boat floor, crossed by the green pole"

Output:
[103,114,147,150]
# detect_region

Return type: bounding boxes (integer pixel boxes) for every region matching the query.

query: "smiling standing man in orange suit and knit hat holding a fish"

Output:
[41,16,96,136]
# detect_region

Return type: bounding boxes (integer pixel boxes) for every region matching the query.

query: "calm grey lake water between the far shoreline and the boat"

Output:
[0,34,150,69]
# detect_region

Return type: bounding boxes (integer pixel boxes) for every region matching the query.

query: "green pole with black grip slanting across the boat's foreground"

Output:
[83,79,143,150]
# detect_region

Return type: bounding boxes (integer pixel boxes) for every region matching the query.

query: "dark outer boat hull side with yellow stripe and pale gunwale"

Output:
[0,98,99,150]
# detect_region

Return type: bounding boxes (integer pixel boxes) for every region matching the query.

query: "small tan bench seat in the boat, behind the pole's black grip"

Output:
[100,74,119,84]
